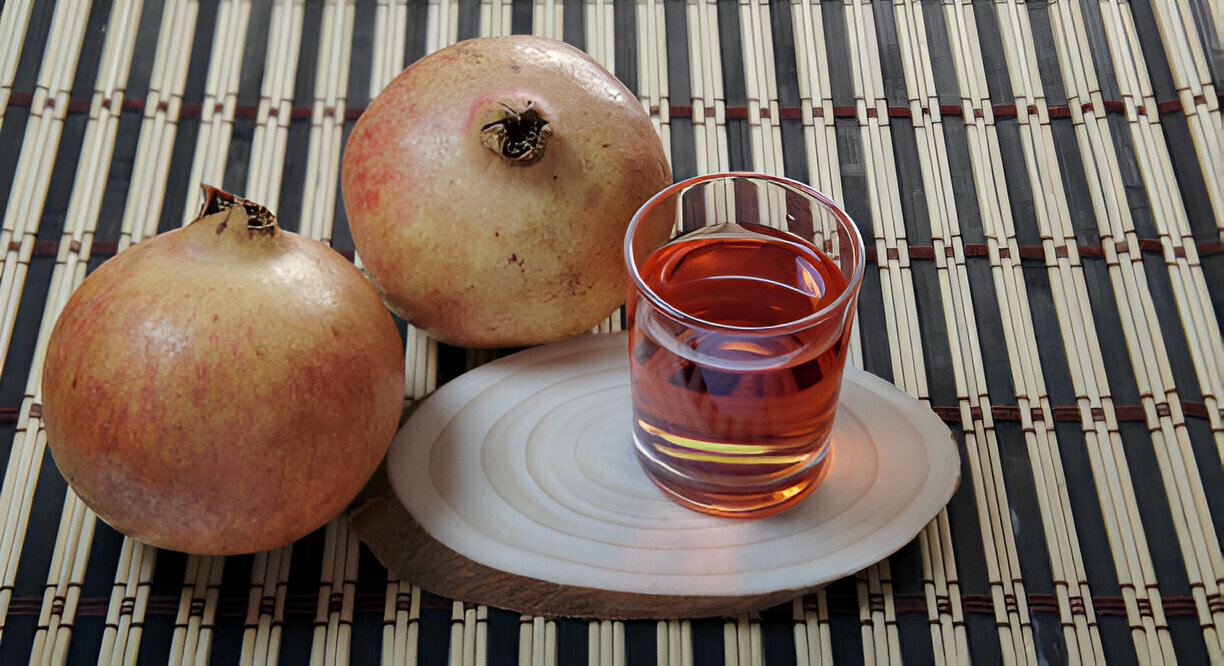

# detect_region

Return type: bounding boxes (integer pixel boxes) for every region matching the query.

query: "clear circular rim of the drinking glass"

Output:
[623,171,867,333]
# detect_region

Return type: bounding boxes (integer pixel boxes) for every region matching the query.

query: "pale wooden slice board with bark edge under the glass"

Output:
[350,334,961,618]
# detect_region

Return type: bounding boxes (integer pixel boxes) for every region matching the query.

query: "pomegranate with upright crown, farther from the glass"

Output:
[43,187,404,555]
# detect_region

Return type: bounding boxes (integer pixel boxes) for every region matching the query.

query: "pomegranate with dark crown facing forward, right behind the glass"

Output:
[343,36,672,346]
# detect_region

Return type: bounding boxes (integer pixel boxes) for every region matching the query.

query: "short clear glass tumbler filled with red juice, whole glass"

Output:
[624,174,863,517]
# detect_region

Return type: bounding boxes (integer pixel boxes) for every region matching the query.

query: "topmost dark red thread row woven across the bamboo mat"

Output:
[9,92,1224,120]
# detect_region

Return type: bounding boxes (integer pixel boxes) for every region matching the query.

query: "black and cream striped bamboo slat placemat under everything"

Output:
[0,0,1224,665]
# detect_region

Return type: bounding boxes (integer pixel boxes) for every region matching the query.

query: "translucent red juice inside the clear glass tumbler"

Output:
[629,224,852,515]
